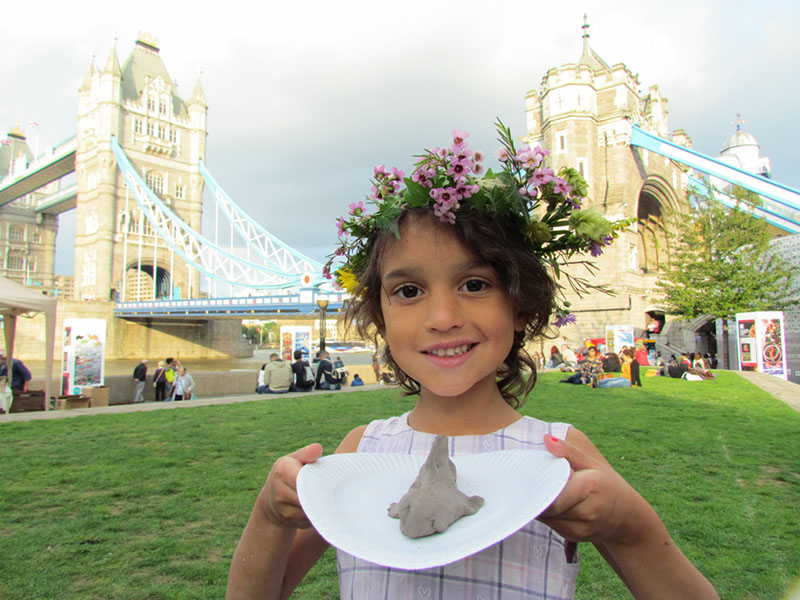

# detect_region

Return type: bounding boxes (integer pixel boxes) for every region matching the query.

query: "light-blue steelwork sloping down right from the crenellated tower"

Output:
[630,125,800,233]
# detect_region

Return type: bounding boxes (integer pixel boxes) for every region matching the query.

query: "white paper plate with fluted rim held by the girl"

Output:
[297,450,569,570]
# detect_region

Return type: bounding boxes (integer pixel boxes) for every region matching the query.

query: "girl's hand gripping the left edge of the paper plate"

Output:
[258,444,322,529]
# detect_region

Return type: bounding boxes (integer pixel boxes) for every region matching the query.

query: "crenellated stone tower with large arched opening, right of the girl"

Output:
[524,17,691,339]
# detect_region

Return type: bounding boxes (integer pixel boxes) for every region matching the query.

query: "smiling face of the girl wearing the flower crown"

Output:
[381,219,524,397]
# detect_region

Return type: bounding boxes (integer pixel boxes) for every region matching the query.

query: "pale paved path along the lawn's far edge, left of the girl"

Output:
[0,383,388,425]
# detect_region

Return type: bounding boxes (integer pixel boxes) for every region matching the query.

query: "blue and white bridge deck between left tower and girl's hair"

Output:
[114,294,347,319]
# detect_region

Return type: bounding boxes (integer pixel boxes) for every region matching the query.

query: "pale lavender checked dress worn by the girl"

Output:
[338,414,579,600]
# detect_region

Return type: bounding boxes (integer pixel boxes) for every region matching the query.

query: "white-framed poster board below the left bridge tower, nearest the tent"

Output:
[61,319,106,394]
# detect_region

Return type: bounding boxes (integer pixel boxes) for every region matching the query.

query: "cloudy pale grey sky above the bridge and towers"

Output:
[0,0,800,273]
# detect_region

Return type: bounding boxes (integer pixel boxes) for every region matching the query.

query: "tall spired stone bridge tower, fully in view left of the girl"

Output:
[75,34,207,300]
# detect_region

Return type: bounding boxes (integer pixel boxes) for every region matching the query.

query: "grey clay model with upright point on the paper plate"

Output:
[389,434,483,538]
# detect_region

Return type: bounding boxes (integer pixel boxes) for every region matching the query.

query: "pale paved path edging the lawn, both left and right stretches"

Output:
[0,371,800,423]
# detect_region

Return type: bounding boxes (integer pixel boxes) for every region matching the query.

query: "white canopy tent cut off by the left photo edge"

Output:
[0,277,56,410]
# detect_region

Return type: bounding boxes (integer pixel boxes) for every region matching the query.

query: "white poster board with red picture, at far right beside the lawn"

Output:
[736,311,789,380]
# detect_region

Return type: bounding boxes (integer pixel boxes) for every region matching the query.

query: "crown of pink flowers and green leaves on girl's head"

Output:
[323,120,631,327]
